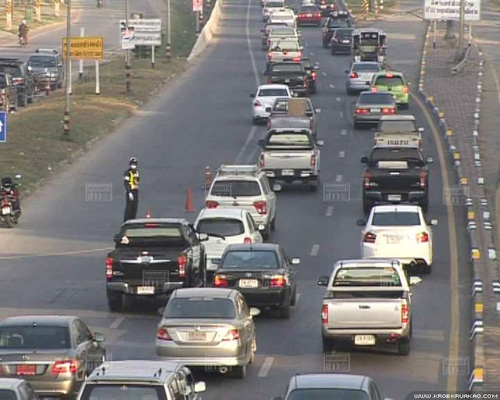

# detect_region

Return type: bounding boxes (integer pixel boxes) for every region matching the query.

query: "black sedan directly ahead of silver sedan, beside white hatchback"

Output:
[214,243,300,319]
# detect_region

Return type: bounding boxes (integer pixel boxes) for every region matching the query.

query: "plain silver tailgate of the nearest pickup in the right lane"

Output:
[327,299,401,329]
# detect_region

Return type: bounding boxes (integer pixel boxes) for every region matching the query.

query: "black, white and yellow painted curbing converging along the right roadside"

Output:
[418,25,500,393]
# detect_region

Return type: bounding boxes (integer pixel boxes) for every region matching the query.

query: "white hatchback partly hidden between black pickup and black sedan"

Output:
[194,207,265,275]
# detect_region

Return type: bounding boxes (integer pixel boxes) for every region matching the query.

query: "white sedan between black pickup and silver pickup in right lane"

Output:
[358,204,437,273]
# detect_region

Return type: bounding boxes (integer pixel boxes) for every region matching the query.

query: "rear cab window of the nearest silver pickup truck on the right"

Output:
[333,267,401,287]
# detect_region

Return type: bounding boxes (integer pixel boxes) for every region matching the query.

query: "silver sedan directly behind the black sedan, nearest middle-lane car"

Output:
[156,288,259,379]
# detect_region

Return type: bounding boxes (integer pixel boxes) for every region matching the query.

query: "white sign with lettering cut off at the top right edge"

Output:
[424,0,481,21]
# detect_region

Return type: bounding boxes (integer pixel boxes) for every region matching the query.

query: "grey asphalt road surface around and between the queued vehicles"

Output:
[0,0,470,399]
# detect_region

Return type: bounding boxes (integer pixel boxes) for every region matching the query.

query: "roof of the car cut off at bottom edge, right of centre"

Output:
[291,374,369,389]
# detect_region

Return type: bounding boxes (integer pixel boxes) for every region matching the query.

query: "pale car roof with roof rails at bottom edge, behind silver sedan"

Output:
[87,360,182,383]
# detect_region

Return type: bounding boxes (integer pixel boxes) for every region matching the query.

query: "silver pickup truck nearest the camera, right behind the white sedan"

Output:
[318,259,422,355]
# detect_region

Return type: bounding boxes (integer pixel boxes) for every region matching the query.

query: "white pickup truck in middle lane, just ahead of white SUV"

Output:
[259,128,323,191]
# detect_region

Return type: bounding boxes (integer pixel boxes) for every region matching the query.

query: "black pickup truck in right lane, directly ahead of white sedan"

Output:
[361,145,433,213]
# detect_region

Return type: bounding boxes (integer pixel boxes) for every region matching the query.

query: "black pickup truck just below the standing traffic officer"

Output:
[106,218,208,311]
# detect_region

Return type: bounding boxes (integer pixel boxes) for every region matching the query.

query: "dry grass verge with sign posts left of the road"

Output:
[0,0,196,194]
